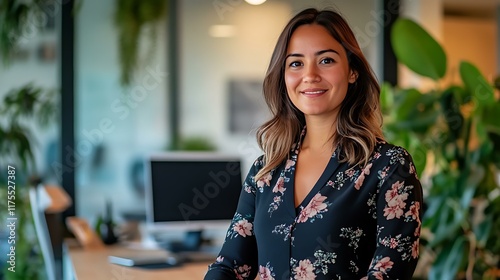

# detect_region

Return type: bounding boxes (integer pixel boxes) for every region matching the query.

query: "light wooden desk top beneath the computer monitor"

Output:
[64,242,208,280]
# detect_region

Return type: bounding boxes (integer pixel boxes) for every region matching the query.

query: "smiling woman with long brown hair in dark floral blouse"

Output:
[205,9,422,280]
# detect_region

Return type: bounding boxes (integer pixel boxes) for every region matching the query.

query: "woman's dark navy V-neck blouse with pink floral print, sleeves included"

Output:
[205,130,422,280]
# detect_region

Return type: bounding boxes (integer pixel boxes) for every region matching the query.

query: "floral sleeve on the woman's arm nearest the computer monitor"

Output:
[204,158,262,280]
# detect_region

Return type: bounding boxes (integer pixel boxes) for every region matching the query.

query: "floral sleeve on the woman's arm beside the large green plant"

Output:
[364,147,423,280]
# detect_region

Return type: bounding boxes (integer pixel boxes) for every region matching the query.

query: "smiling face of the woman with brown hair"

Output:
[285,24,356,121]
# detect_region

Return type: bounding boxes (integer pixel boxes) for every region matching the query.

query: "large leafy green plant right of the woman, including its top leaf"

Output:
[381,18,500,280]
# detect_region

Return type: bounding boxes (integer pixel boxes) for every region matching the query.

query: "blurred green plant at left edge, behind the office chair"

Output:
[0,84,57,279]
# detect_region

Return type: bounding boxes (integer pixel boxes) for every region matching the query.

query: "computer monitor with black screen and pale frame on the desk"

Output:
[146,152,242,231]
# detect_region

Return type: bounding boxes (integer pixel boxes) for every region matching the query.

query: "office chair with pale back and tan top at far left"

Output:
[29,184,72,280]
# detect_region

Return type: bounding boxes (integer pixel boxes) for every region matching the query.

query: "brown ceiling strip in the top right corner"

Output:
[443,0,500,18]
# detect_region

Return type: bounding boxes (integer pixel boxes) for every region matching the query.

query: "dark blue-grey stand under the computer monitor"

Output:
[166,230,218,262]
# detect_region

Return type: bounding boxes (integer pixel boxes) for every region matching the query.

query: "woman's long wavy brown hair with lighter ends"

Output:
[256,8,384,180]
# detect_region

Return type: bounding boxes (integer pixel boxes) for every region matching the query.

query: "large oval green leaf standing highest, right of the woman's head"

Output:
[391,18,446,81]
